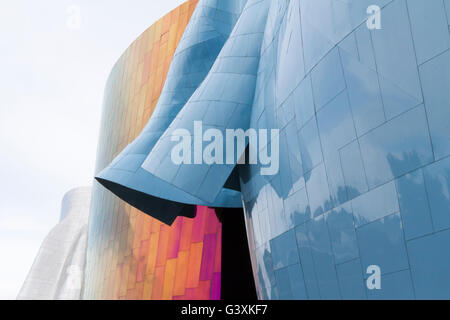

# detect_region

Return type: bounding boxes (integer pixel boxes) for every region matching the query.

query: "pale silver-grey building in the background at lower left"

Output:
[17,187,91,300]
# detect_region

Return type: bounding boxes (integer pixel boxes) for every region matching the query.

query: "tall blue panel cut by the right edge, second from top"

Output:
[420,51,450,160]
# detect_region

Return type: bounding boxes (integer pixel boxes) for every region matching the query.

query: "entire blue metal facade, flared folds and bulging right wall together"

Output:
[88,0,450,299]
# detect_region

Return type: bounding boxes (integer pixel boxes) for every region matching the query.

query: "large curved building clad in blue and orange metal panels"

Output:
[85,0,450,299]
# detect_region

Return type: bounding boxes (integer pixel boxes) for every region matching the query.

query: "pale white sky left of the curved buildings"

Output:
[0,0,184,299]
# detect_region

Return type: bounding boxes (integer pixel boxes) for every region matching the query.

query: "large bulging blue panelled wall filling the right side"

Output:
[241,0,450,299]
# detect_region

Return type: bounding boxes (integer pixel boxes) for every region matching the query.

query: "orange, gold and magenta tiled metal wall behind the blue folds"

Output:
[84,0,221,299]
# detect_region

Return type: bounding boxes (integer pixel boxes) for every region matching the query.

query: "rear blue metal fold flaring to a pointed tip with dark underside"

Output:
[96,1,250,225]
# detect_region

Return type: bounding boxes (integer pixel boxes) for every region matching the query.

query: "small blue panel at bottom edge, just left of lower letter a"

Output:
[336,259,367,300]
